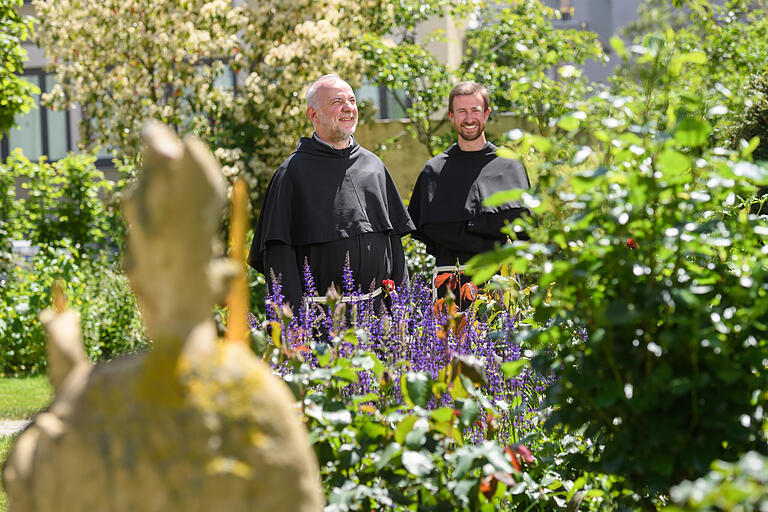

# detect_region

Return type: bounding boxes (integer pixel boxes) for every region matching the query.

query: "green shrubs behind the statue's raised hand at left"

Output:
[0,151,147,375]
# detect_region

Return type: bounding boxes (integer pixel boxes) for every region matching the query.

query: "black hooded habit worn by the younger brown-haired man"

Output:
[408,142,531,266]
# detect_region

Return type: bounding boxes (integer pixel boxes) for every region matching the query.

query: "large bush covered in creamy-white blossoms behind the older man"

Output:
[34,0,373,204]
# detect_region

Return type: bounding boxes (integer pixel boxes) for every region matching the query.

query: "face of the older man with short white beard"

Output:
[307,80,357,144]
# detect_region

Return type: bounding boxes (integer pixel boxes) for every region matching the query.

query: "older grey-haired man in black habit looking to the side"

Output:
[248,75,414,308]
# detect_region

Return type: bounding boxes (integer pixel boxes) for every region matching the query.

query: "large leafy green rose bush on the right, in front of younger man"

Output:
[471,34,768,496]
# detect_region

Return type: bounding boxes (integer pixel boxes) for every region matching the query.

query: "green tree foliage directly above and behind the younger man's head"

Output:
[361,0,605,155]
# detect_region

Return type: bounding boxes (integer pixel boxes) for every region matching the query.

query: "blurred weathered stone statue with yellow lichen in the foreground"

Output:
[3,123,323,512]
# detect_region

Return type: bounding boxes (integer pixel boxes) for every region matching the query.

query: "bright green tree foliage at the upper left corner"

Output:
[0,0,40,139]
